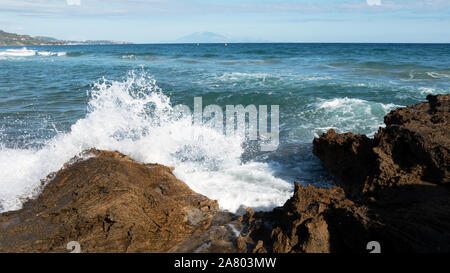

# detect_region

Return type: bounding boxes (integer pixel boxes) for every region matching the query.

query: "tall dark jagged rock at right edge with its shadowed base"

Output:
[314,95,450,252]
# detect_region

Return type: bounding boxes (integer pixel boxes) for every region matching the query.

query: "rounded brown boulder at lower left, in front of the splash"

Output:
[0,150,241,252]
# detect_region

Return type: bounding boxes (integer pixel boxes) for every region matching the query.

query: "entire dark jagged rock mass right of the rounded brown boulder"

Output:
[238,95,450,253]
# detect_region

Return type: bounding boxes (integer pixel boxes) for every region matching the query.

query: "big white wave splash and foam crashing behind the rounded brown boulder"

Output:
[0,69,293,211]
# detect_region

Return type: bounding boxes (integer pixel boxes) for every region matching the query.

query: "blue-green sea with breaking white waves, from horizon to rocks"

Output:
[0,44,450,212]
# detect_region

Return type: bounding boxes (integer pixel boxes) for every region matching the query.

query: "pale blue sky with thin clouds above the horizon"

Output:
[0,0,450,43]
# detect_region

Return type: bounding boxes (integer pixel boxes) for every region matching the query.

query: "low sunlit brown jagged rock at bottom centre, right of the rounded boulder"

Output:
[243,183,379,253]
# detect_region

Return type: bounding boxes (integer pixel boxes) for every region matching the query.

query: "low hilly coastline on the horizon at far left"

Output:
[0,30,129,46]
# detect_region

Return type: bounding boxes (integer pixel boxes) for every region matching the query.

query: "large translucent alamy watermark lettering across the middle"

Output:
[173,97,280,151]
